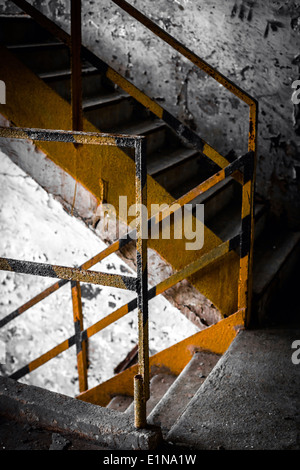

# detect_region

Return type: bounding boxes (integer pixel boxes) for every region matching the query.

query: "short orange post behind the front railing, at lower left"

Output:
[71,281,88,393]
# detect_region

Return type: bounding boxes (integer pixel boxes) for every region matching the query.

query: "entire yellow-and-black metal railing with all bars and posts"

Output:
[0,0,257,427]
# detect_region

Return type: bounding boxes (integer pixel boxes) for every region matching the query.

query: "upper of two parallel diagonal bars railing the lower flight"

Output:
[0,152,253,328]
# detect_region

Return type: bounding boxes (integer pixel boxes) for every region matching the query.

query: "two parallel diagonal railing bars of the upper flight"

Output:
[12,0,257,174]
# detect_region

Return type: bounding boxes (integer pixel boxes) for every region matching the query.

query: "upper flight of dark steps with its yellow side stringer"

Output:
[0,15,299,326]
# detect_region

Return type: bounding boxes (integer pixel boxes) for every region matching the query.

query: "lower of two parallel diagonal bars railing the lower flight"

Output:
[10,234,240,380]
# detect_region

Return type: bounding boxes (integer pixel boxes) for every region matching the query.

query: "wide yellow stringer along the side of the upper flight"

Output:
[0,46,239,316]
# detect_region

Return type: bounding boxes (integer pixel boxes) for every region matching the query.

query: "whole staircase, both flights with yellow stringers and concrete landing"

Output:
[0,9,300,449]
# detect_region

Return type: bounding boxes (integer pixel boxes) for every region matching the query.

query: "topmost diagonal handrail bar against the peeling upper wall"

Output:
[112,0,256,105]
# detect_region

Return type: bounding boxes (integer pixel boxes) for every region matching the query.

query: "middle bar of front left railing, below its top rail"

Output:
[0,258,137,291]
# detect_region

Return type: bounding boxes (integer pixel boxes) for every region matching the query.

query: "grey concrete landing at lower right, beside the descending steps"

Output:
[167,327,300,450]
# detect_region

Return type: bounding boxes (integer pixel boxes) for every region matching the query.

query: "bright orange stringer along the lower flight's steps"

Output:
[76,311,244,406]
